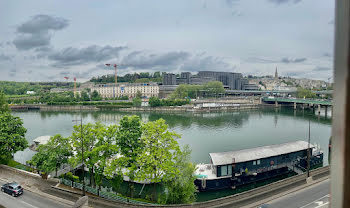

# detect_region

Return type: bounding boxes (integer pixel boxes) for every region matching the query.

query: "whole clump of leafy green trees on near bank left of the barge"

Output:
[27,116,196,204]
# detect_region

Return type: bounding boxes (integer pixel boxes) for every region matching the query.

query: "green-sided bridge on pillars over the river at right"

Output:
[262,97,333,115]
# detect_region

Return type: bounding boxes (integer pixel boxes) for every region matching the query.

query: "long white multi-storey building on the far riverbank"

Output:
[91,83,159,98]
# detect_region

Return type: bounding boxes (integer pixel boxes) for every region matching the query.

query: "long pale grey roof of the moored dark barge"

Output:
[209,141,314,165]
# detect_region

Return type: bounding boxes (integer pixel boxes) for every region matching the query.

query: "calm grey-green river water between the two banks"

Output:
[13,108,331,199]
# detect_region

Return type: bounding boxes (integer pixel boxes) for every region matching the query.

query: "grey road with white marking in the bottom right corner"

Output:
[266,179,330,208]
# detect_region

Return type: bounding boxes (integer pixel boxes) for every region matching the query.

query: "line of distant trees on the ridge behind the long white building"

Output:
[90,72,162,83]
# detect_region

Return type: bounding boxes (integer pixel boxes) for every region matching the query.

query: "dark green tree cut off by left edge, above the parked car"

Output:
[0,111,28,159]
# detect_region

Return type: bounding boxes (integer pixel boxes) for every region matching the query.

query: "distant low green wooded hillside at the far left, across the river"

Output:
[0,81,73,95]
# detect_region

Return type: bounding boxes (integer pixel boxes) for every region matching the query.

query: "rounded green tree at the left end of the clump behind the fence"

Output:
[27,134,73,177]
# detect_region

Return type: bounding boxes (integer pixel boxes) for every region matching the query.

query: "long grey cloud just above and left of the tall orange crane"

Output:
[48,45,126,67]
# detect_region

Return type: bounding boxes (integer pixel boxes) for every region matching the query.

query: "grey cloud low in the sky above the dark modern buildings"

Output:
[122,51,190,69]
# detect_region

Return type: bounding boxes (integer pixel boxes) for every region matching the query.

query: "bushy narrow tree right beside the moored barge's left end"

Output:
[165,145,197,204]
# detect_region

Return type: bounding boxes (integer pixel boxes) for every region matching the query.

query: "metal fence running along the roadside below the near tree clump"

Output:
[60,178,152,205]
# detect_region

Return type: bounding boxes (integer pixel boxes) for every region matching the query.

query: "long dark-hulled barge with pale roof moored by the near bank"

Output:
[195,141,323,191]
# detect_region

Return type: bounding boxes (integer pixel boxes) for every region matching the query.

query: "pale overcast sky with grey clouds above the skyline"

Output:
[0,0,335,82]
